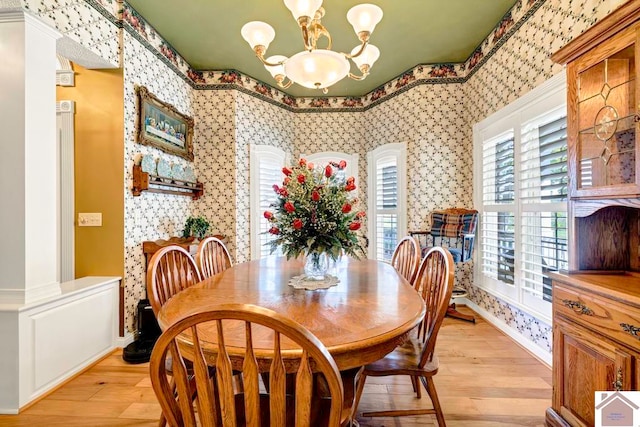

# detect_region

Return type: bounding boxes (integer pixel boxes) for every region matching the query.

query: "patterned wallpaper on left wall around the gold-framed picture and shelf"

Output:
[123,31,195,331]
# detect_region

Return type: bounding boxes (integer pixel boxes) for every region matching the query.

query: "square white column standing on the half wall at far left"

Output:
[0,8,61,304]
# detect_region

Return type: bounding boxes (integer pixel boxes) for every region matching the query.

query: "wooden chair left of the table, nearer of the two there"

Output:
[147,245,202,316]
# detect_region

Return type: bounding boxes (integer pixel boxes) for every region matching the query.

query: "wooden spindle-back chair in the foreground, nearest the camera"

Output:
[149,304,347,427]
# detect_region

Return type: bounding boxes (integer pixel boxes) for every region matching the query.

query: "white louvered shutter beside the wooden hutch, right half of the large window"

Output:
[520,113,568,308]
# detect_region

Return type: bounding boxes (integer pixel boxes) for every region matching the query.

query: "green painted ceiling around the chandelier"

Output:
[128,0,517,96]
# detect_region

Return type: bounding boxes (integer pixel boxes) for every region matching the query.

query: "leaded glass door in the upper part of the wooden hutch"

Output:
[576,44,638,192]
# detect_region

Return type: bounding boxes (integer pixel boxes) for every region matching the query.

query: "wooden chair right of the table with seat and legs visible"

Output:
[354,247,454,427]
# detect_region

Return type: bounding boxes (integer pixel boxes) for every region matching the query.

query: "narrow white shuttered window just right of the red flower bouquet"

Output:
[368,144,407,261]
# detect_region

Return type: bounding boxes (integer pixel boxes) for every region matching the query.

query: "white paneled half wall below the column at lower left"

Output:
[0,277,121,414]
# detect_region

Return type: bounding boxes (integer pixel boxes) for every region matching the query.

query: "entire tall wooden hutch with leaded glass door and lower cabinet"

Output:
[546,5,640,427]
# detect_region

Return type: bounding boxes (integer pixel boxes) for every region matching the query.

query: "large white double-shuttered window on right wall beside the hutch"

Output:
[474,73,568,319]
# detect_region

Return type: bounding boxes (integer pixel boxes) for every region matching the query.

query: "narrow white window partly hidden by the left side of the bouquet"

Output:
[250,144,286,259]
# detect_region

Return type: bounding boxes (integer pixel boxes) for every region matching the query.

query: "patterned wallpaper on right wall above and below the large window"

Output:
[462,0,611,352]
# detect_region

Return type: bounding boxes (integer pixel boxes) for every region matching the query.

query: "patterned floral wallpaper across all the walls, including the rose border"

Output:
[24,0,618,351]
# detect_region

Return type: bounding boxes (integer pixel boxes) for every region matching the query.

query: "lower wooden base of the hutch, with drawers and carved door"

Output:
[546,273,640,426]
